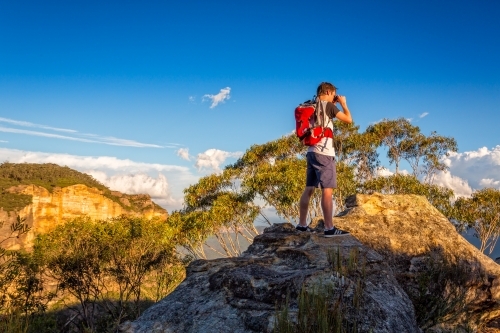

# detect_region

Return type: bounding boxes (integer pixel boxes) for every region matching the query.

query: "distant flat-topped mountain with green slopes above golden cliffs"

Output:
[0,163,168,249]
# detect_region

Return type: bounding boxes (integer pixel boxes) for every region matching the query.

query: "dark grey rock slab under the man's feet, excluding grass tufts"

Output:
[122,224,419,332]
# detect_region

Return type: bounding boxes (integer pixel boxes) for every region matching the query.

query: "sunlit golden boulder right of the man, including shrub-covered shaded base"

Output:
[335,194,500,332]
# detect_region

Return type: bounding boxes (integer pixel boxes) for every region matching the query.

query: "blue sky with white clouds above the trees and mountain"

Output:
[0,0,500,210]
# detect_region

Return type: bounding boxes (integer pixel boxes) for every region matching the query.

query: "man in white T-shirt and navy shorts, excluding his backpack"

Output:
[296,82,352,237]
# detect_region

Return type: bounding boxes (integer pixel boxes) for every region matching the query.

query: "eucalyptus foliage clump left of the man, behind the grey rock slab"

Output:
[176,136,305,258]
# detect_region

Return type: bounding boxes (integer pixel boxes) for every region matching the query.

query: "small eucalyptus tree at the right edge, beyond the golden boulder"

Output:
[453,188,500,254]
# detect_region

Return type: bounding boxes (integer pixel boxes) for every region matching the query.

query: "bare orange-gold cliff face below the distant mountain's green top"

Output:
[0,185,167,250]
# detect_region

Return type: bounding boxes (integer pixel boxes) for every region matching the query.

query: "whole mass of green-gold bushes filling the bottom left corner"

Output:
[0,216,185,332]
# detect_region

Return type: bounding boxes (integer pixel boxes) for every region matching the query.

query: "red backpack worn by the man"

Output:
[295,100,333,146]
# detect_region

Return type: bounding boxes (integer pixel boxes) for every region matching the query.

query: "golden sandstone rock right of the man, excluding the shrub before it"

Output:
[335,194,500,328]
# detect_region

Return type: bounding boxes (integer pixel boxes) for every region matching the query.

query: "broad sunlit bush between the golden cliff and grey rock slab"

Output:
[34,216,184,332]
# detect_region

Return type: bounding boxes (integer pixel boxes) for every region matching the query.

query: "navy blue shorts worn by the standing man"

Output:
[306,152,337,188]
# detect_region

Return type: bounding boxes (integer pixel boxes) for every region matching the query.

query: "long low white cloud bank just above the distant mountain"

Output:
[0,148,199,210]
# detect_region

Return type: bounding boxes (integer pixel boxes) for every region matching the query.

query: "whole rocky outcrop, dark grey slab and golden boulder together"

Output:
[121,194,500,333]
